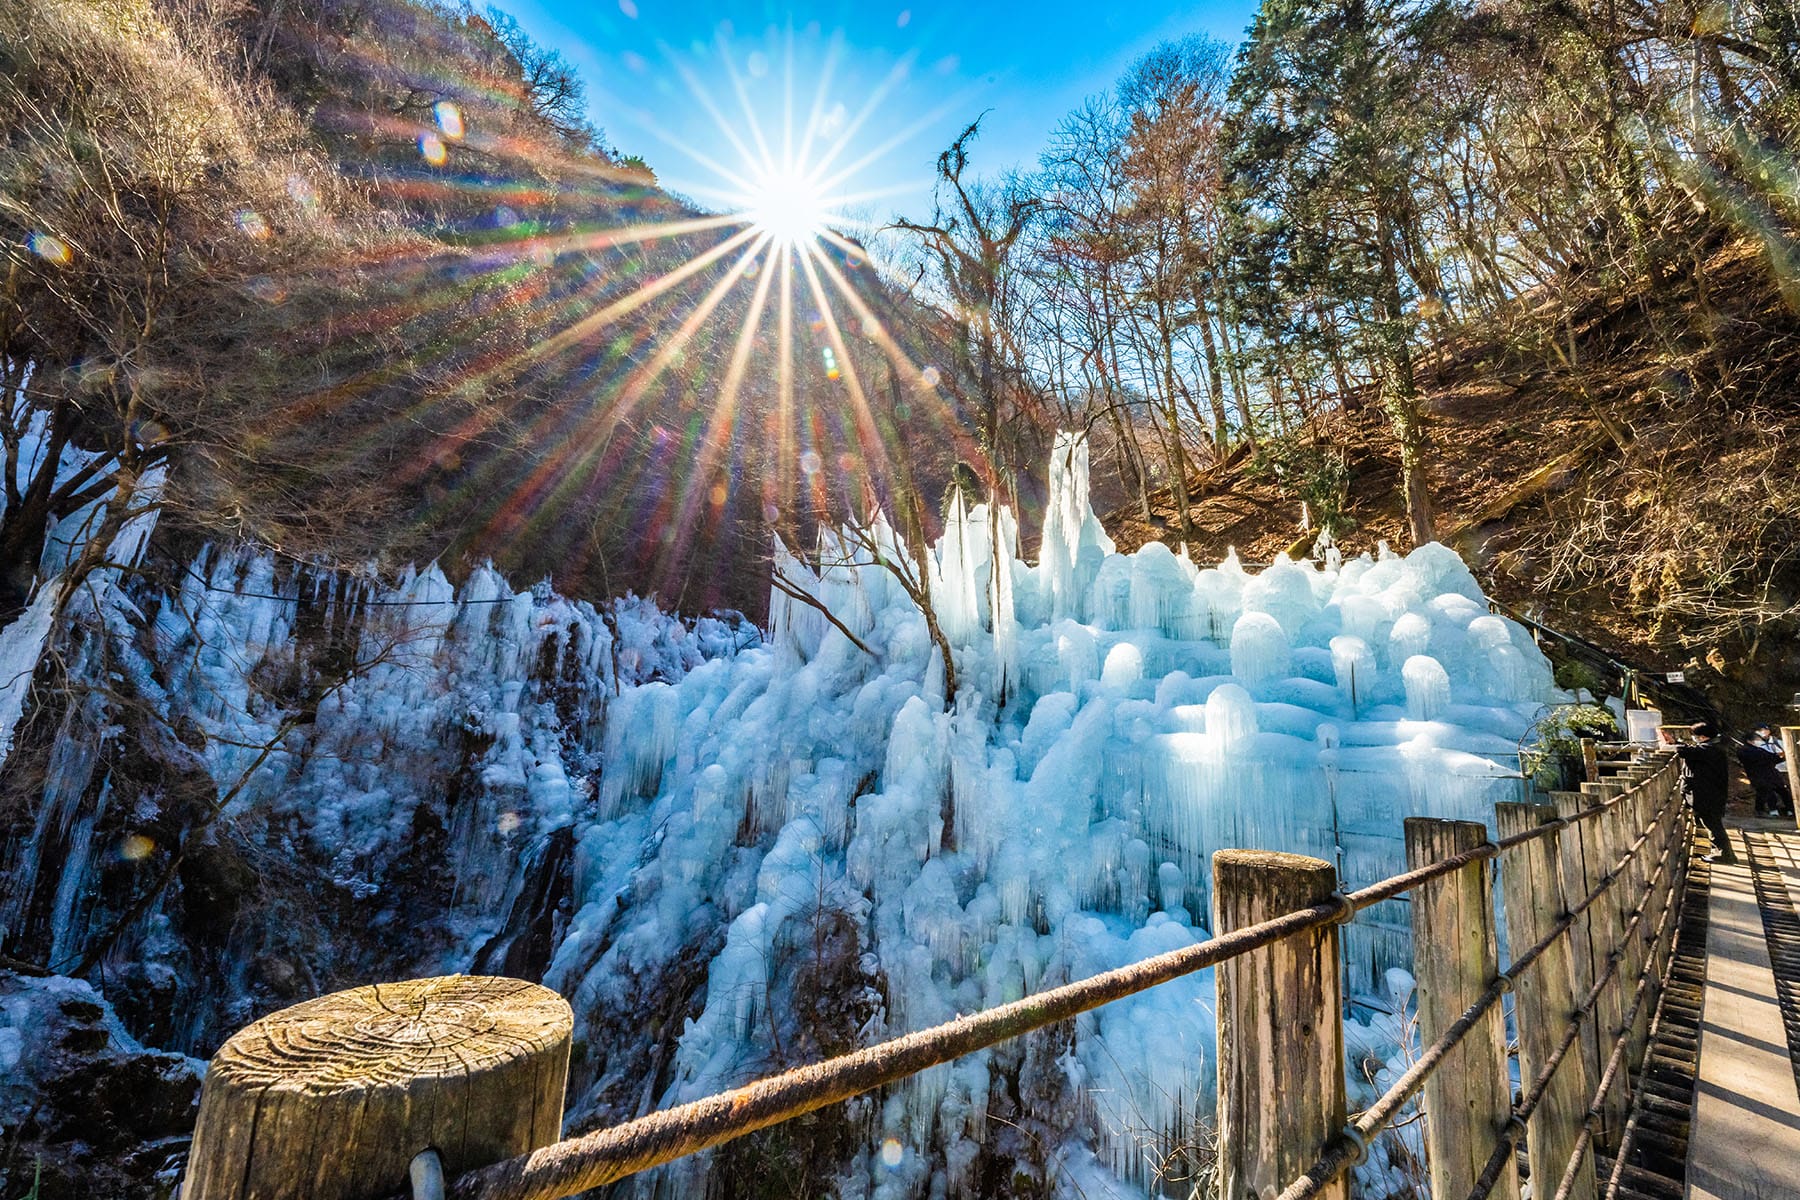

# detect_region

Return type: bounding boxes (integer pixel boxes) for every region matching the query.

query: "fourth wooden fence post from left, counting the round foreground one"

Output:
[1494,804,1595,1200]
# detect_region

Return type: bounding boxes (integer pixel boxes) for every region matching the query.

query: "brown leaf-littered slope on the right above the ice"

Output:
[1107,243,1800,718]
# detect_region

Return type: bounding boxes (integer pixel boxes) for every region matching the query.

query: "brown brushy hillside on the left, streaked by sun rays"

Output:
[0,0,968,622]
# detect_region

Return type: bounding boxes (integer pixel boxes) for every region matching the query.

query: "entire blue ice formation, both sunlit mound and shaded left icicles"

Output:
[0,429,1552,1198]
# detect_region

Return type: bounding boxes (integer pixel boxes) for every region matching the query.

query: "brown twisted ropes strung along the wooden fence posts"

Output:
[424,763,1685,1200]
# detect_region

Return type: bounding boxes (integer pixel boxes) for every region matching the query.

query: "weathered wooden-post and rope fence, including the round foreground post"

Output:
[171,756,1688,1200]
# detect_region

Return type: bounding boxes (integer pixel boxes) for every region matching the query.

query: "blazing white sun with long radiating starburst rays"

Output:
[309,16,967,600]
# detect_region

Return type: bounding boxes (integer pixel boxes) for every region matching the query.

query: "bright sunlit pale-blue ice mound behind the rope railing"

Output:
[568,437,1552,1196]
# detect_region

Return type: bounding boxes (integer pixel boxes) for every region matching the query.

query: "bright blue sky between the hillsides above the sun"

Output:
[499,0,1255,219]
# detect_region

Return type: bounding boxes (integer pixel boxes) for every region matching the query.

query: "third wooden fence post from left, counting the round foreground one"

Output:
[1406,817,1519,1200]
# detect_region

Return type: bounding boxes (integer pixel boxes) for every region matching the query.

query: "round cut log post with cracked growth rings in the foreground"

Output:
[182,975,574,1200]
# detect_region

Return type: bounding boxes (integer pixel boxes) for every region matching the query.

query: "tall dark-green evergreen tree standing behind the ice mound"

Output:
[1226,0,1445,543]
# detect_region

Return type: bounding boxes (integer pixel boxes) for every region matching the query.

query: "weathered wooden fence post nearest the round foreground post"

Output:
[1213,849,1350,1200]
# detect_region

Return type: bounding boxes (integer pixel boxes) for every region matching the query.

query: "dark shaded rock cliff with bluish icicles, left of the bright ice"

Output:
[0,552,758,1198]
